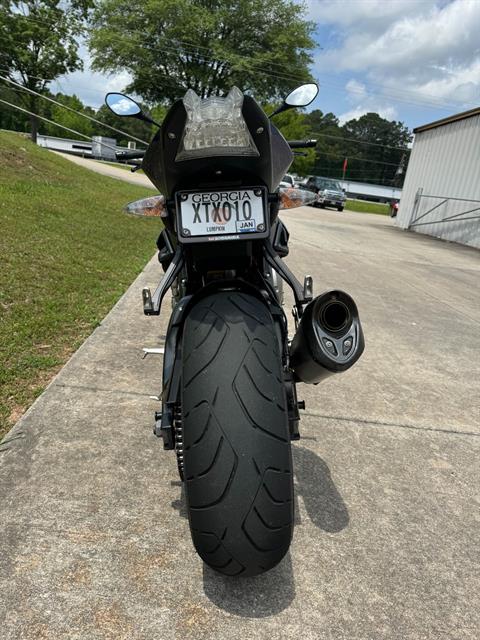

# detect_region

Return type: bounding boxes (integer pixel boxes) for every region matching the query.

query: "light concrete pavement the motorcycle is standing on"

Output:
[0,198,480,640]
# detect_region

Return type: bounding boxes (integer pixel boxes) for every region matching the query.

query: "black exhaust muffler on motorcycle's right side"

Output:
[290,291,365,384]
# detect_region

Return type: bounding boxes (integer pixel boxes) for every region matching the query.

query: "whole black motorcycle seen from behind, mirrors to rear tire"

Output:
[105,84,364,576]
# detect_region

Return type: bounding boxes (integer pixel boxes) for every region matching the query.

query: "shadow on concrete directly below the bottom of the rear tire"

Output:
[203,553,295,618]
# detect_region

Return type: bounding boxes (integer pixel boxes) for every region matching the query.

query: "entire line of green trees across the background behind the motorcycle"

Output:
[0,0,411,185]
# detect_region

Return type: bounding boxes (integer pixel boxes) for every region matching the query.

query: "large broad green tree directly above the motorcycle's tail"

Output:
[90,0,315,104]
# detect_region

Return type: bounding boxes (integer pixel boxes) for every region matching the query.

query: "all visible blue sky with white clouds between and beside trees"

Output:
[52,0,480,129]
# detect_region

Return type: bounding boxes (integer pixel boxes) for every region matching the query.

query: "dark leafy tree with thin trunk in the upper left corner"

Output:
[0,0,92,142]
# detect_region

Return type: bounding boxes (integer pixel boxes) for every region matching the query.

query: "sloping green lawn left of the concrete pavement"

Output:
[0,131,159,438]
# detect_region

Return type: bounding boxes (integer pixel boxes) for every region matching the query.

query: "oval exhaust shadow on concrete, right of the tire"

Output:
[292,445,350,533]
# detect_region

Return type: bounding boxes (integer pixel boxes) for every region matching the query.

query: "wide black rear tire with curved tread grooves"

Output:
[182,291,293,576]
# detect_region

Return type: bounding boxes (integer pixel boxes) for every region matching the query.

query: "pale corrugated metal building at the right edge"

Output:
[396,108,480,248]
